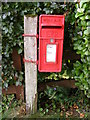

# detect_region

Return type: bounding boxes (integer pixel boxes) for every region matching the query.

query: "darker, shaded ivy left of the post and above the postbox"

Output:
[2,2,74,88]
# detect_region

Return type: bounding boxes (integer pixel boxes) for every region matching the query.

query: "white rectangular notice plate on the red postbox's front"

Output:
[46,44,56,62]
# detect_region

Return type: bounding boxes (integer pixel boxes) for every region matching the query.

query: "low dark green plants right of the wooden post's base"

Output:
[38,86,89,118]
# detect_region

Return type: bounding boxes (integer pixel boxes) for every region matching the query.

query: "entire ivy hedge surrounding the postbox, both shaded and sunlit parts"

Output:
[2,2,90,97]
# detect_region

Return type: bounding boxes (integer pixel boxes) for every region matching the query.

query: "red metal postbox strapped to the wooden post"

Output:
[39,15,65,72]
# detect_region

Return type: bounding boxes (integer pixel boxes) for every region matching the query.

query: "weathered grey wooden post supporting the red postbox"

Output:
[24,16,37,114]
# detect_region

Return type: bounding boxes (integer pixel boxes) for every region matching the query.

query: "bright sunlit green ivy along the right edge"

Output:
[72,1,90,98]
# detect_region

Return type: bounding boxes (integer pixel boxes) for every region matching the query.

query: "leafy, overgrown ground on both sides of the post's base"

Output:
[2,87,90,120]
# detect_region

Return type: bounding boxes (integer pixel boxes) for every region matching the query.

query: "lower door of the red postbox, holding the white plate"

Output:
[39,40,63,72]
